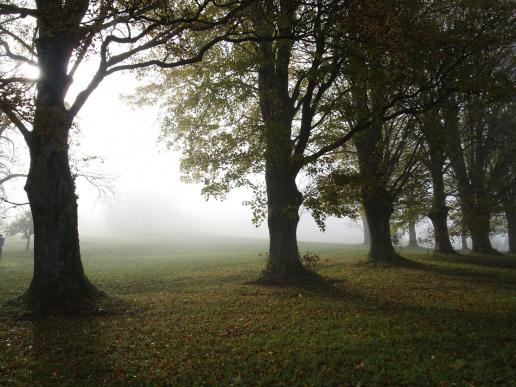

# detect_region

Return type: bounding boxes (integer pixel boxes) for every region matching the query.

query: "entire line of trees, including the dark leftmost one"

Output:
[0,0,514,306]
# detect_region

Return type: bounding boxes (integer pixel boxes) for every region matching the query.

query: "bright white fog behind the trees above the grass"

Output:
[4,68,362,243]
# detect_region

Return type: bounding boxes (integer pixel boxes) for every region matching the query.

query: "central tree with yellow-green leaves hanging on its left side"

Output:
[157,0,363,282]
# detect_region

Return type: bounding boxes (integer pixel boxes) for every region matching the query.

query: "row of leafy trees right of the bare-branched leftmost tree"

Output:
[152,1,516,270]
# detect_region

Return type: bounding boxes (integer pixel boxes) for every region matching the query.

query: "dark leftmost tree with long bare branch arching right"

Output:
[0,0,250,307]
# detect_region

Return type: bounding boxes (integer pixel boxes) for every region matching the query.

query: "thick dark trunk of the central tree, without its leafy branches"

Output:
[254,3,307,282]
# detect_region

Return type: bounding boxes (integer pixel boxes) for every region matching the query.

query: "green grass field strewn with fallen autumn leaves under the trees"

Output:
[0,238,516,386]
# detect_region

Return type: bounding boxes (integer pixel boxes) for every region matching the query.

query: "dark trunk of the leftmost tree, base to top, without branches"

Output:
[25,1,99,308]
